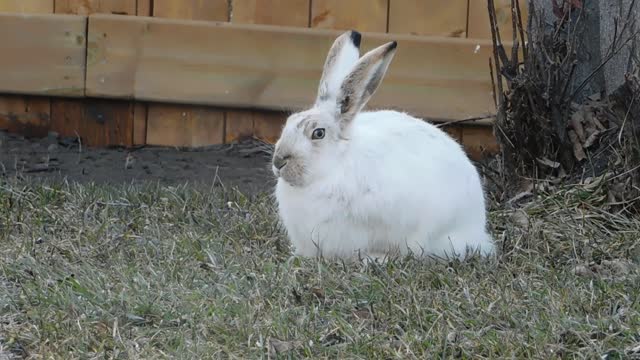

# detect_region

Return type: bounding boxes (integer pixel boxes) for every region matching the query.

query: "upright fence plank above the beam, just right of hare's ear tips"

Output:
[389,0,468,37]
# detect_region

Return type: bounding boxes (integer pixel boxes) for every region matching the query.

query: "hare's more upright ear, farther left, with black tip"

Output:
[316,30,362,106]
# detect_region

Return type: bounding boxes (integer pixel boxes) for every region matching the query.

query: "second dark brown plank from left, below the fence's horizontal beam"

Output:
[51,99,133,147]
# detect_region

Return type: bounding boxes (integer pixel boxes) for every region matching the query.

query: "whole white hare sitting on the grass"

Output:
[272,31,494,258]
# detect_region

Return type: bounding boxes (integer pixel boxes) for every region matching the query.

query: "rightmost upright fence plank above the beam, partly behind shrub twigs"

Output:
[467,0,529,43]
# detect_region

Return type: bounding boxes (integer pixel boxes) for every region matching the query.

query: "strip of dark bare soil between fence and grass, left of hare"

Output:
[0,132,275,195]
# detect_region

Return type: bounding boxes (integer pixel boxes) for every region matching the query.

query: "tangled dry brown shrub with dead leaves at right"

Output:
[488,0,640,210]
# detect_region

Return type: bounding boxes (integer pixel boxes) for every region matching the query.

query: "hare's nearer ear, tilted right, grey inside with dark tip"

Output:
[336,41,397,128]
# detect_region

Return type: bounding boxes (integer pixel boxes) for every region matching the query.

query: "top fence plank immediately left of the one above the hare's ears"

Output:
[231,0,310,27]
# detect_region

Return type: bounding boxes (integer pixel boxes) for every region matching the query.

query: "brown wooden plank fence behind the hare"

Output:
[0,0,524,158]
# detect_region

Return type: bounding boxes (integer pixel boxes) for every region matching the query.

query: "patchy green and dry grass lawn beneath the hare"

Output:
[0,182,640,359]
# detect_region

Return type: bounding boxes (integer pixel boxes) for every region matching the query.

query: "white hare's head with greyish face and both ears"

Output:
[272,31,396,187]
